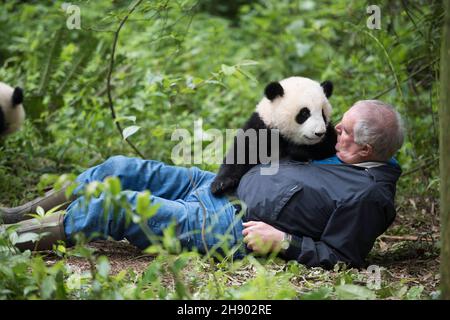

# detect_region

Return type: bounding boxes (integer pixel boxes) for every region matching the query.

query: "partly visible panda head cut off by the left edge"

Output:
[0,82,25,136]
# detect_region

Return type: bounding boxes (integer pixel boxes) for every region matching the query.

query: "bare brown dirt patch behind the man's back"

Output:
[368,197,440,294]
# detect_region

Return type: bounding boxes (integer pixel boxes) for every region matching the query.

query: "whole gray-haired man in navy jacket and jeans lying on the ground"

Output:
[0,100,403,268]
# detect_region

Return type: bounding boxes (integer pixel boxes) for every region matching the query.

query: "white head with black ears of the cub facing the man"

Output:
[256,77,333,145]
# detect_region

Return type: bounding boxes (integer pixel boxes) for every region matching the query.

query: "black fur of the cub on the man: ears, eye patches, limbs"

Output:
[211,81,337,196]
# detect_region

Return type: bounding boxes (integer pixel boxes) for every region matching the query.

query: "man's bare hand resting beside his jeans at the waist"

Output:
[242,221,284,254]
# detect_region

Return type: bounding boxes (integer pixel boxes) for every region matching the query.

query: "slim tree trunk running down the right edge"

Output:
[439,0,450,300]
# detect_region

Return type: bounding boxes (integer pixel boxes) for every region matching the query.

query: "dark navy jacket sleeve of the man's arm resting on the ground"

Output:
[282,199,395,269]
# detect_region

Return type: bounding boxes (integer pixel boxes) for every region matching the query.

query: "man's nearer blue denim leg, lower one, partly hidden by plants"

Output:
[64,186,242,253]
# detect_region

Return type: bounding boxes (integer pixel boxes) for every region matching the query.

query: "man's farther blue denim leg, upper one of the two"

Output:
[75,156,215,200]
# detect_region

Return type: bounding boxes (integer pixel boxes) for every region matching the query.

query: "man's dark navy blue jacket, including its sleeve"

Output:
[237,160,401,269]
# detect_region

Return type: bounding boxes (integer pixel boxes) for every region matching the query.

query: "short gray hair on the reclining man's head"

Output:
[353,100,405,161]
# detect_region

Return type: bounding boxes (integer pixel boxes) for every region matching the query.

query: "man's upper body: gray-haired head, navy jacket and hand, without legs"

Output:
[238,101,404,268]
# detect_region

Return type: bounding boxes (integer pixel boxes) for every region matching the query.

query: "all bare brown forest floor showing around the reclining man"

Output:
[39,191,439,297]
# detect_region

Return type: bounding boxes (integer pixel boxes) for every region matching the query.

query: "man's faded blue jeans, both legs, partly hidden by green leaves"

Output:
[64,156,243,257]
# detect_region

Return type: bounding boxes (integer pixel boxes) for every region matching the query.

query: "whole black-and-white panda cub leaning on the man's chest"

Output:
[211,77,337,195]
